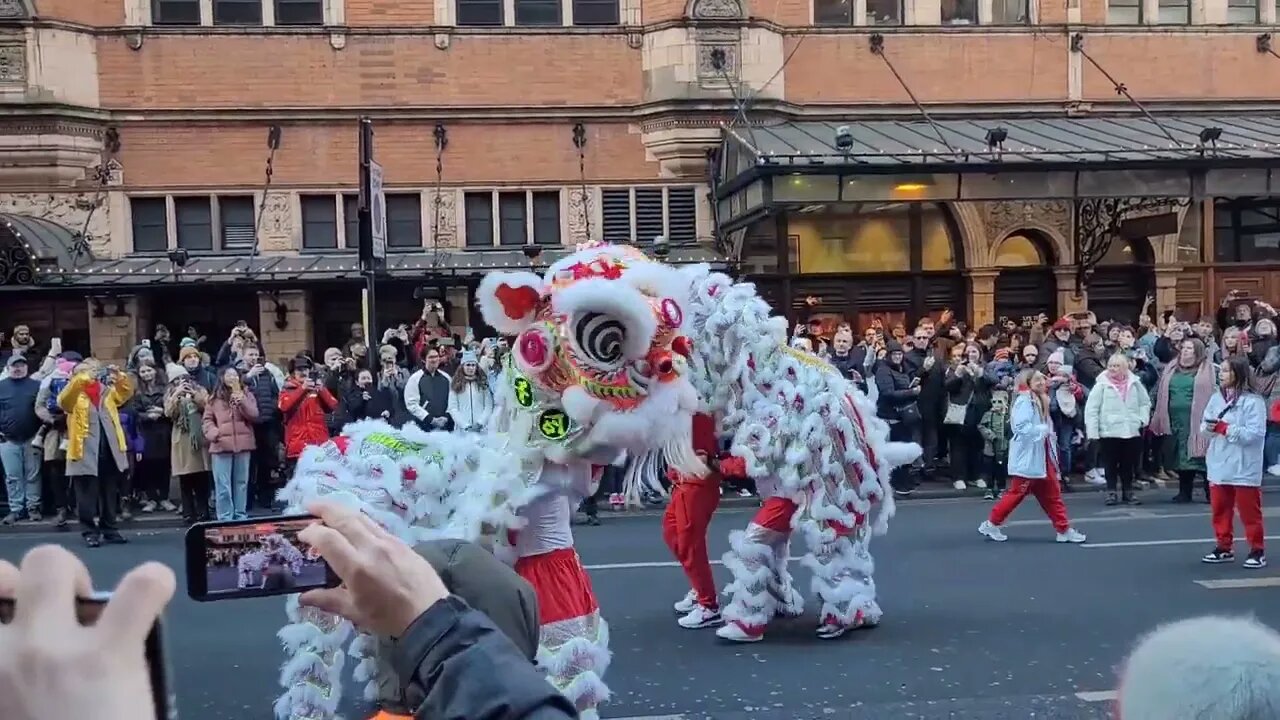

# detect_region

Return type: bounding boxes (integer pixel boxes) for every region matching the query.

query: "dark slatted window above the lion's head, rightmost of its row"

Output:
[600,186,698,242]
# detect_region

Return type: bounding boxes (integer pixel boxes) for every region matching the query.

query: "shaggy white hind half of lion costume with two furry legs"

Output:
[689,270,920,642]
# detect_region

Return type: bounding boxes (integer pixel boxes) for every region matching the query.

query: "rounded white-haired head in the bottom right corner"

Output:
[1119,616,1280,720]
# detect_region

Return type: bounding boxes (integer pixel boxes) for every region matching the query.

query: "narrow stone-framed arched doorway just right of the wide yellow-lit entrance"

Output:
[995,231,1057,323]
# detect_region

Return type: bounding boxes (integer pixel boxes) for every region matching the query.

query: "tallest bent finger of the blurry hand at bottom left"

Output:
[13,544,93,637]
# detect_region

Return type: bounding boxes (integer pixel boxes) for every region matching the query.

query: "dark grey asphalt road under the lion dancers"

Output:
[0,491,1280,720]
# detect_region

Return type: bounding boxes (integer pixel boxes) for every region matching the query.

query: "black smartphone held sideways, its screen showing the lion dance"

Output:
[187,515,342,602]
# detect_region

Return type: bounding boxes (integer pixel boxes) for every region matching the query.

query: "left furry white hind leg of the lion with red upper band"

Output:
[716,497,795,642]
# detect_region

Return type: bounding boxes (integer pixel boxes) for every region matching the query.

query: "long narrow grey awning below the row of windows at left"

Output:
[27,245,721,290]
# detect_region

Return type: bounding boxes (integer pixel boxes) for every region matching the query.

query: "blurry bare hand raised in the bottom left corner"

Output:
[0,544,175,720]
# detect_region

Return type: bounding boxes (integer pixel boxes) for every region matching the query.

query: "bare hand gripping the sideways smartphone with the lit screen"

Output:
[298,500,449,638]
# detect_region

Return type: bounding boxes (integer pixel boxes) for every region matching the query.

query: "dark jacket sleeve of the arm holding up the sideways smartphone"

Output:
[393,597,577,720]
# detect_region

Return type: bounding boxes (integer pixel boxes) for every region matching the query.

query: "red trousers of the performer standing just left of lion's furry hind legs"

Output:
[662,475,719,610]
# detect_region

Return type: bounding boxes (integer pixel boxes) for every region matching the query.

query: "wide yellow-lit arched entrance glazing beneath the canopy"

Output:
[786,202,966,329]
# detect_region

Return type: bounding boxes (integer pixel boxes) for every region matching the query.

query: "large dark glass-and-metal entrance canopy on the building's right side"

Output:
[716,114,1280,234]
